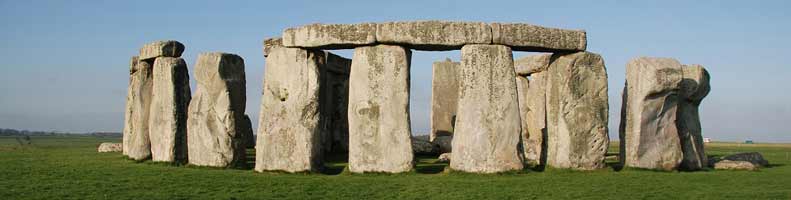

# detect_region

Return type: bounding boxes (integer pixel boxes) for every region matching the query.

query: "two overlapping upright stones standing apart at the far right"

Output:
[619,57,710,171]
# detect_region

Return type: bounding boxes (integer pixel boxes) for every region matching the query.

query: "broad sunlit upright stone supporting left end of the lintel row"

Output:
[255,47,326,172]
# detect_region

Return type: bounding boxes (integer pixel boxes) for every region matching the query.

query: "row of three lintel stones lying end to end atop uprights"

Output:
[282,20,587,52]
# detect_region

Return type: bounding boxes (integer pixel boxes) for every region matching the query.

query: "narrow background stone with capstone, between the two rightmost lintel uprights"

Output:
[514,54,552,165]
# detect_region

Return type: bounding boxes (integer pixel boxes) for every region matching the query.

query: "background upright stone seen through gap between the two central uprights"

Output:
[429,59,460,141]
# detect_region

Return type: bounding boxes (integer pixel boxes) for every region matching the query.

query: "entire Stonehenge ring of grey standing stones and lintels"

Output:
[119,21,711,173]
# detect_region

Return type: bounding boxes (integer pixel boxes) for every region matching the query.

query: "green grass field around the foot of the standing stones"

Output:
[0,136,791,199]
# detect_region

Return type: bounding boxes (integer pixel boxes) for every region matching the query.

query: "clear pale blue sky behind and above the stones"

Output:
[0,0,791,142]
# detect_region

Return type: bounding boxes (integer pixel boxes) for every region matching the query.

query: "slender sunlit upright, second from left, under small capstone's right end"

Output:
[148,57,191,162]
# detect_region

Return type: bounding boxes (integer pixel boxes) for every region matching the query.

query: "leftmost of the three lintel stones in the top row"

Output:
[283,23,376,49]
